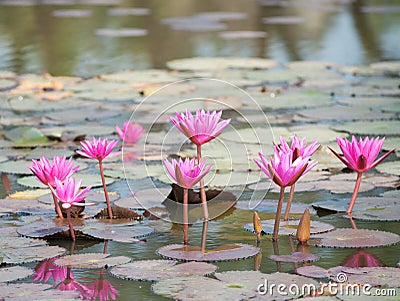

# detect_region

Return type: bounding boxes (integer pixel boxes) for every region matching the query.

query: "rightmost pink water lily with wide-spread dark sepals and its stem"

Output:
[328,135,394,214]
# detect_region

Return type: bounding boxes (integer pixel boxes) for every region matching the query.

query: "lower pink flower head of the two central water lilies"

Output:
[164,158,212,188]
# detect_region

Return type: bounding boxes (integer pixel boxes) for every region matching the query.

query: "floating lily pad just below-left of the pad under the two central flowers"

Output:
[110,260,217,281]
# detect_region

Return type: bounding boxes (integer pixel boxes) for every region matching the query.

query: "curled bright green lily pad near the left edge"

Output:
[5,126,55,147]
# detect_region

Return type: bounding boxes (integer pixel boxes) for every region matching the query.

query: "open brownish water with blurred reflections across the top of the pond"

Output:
[0,0,400,76]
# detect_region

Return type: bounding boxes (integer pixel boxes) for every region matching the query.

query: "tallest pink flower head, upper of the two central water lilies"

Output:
[171,109,231,145]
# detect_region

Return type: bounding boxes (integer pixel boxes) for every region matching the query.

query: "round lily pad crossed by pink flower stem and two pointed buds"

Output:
[243,219,335,235]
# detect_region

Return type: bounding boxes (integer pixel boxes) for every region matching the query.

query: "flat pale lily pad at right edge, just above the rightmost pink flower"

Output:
[331,120,400,136]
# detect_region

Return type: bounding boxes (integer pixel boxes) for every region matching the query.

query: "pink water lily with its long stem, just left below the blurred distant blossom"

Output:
[76,137,118,219]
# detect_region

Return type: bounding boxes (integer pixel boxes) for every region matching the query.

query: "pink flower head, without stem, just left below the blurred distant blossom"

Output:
[76,137,118,161]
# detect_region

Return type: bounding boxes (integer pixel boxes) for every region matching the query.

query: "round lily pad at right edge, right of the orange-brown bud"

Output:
[309,228,400,248]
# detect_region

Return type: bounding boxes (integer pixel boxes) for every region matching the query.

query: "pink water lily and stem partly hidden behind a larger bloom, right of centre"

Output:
[275,135,320,221]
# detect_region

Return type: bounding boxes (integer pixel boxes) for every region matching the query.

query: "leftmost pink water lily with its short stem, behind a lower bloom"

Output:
[28,156,79,219]
